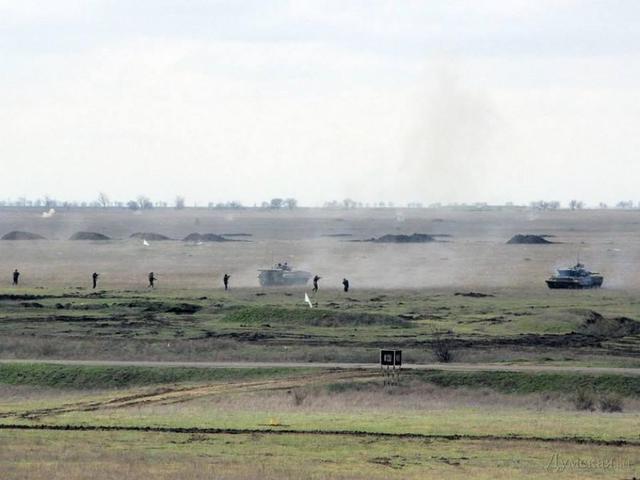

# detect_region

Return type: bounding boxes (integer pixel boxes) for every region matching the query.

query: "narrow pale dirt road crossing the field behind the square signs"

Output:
[0,359,640,376]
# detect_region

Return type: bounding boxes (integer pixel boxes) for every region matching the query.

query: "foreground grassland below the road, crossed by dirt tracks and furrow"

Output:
[0,364,640,479]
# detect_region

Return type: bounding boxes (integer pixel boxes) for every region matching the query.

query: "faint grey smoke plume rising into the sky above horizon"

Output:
[398,71,504,202]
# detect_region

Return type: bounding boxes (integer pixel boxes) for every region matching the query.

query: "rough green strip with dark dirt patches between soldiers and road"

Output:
[0,289,640,367]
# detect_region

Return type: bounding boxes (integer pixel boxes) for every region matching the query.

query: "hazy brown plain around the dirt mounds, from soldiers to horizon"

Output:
[0,208,640,291]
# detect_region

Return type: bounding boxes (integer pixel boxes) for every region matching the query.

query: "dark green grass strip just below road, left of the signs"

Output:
[0,363,315,390]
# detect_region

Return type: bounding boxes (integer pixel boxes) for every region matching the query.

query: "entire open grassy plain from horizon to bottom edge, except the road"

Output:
[0,209,640,480]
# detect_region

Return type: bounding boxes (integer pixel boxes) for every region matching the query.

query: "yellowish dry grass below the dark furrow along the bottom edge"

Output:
[0,431,637,480]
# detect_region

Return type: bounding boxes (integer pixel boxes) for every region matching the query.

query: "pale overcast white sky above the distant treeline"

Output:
[0,0,640,206]
